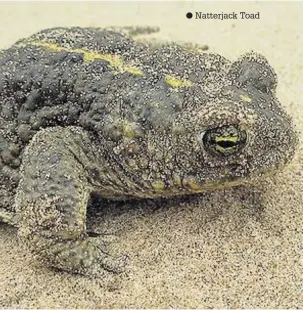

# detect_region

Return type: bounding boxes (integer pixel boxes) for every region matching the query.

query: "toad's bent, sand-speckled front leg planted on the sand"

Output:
[15,127,124,276]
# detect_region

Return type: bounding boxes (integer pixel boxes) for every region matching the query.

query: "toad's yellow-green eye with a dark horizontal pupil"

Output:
[201,126,247,156]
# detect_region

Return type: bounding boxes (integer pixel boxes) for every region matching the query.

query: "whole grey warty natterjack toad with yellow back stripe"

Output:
[0,28,297,276]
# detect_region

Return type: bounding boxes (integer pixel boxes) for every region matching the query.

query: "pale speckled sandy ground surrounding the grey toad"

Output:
[0,1,303,309]
